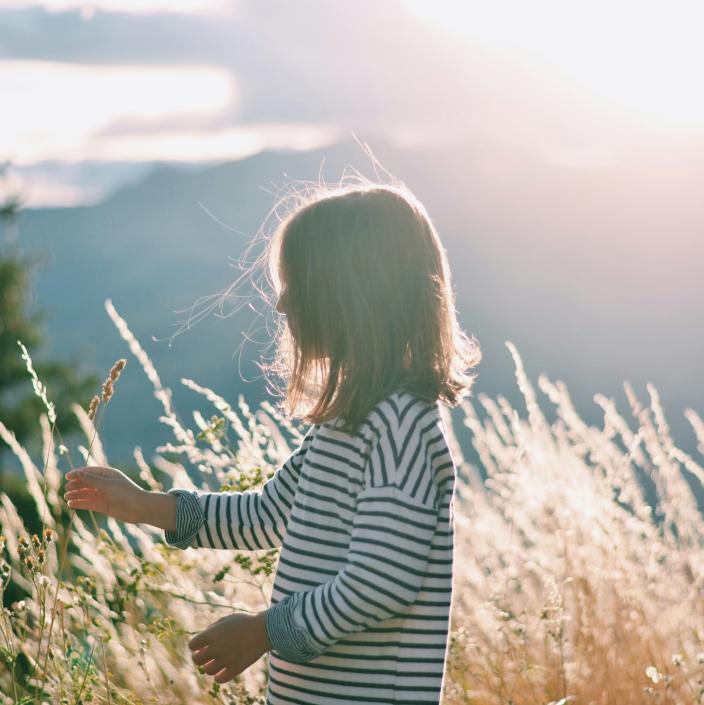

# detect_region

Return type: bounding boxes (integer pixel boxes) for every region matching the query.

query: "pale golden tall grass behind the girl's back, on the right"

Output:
[447,343,704,705]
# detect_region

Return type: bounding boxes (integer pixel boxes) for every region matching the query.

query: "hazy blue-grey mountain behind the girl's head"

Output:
[6,139,704,478]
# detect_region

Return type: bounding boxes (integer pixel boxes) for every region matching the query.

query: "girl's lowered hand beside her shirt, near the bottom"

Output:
[188,612,271,683]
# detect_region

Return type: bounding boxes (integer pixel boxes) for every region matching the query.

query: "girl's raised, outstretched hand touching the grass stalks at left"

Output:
[64,465,148,524]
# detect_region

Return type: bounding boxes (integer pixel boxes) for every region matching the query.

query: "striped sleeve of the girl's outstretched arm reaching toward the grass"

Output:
[164,425,316,551]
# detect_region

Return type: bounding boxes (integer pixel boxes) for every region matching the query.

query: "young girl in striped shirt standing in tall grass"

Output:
[65,177,481,705]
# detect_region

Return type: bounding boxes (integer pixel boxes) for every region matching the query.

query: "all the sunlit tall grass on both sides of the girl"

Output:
[0,301,704,705]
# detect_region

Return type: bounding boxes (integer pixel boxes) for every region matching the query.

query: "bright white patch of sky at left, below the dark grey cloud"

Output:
[0,60,236,164]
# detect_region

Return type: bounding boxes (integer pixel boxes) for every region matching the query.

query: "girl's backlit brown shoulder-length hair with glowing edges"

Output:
[262,175,481,433]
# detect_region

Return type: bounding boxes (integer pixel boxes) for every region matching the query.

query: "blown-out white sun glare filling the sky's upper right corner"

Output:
[406,0,704,132]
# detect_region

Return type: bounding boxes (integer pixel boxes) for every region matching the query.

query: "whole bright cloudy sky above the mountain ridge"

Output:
[0,0,704,206]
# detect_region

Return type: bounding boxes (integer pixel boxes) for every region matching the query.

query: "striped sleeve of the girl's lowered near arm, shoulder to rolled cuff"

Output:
[265,402,438,663]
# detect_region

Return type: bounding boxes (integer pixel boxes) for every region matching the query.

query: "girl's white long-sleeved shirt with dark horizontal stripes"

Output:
[164,389,455,705]
